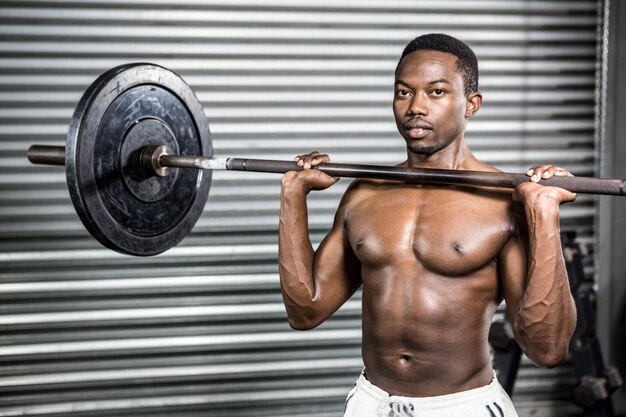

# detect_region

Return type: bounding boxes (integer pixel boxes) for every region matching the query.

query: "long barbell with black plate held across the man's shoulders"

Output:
[27,63,626,256]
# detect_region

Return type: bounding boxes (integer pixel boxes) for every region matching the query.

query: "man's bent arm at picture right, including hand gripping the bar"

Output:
[500,165,576,367]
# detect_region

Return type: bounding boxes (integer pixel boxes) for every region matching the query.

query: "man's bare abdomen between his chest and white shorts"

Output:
[362,264,497,397]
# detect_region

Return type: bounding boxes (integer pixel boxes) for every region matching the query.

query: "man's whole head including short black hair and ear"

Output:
[393,34,482,157]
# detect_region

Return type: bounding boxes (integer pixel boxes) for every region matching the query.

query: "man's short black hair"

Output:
[396,33,478,94]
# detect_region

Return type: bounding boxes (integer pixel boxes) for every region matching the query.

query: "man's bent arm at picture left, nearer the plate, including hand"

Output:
[278,154,361,330]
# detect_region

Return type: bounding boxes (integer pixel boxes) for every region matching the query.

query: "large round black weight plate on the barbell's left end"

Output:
[65,63,213,256]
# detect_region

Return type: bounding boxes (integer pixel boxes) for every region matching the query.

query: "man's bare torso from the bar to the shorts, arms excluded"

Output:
[345,181,513,396]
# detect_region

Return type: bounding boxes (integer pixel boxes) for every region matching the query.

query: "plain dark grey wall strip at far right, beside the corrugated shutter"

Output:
[596,1,626,415]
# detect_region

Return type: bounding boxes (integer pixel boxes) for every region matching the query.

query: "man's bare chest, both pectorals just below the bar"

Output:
[346,187,512,276]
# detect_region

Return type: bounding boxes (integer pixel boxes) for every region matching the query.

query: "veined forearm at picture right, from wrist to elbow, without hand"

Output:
[514,205,576,366]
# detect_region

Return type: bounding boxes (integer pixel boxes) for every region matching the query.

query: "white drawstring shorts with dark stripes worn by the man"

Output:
[344,373,517,417]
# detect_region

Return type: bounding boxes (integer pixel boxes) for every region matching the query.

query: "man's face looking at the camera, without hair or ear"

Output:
[393,51,468,155]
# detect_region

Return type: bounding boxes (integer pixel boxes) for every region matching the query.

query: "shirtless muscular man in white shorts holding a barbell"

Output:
[279,34,576,417]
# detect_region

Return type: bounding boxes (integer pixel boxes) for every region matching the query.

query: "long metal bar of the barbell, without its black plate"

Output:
[27,145,626,196]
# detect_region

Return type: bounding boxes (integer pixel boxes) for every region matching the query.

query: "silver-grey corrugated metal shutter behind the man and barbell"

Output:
[0,0,599,417]
